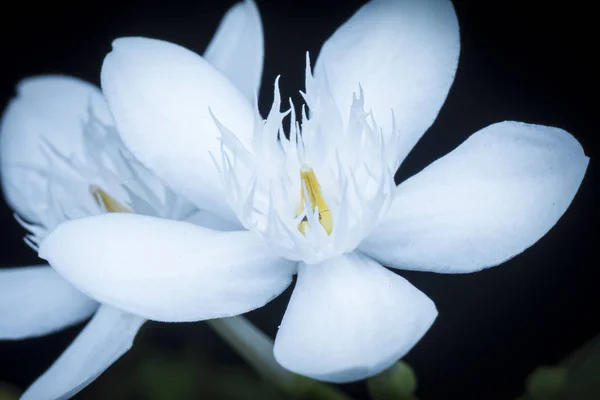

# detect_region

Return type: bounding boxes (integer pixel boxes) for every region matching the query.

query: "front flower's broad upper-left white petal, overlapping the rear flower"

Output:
[102,38,254,219]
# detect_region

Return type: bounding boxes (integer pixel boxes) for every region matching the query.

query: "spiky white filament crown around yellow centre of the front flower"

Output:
[217,57,399,264]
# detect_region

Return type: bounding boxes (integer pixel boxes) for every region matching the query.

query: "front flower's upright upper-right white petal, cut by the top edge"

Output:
[315,0,460,161]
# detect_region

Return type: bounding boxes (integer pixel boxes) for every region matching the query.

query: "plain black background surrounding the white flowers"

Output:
[0,0,600,400]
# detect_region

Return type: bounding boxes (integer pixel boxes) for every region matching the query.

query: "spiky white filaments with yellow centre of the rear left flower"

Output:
[14,108,195,249]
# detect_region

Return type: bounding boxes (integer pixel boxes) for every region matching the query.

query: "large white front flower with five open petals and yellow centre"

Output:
[40,0,588,382]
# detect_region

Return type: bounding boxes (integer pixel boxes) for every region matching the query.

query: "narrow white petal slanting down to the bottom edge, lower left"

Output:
[21,305,145,400]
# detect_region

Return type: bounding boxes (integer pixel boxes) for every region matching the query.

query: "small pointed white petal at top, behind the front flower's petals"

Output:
[204,0,264,102]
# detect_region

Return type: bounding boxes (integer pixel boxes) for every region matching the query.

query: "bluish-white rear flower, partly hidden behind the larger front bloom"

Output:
[0,1,268,399]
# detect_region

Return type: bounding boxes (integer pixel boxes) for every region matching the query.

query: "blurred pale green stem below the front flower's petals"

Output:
[206,316,351,400]
